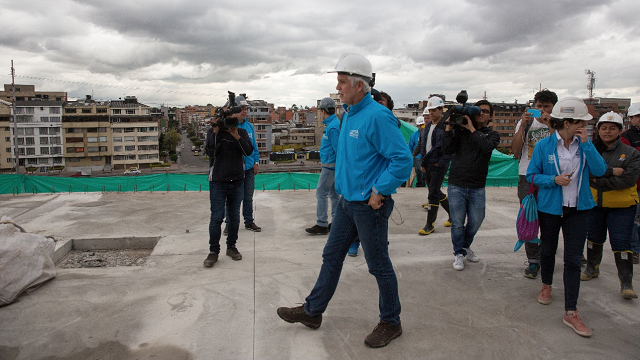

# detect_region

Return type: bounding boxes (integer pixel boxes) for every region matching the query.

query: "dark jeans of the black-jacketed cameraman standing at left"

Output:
[209,180,244,254]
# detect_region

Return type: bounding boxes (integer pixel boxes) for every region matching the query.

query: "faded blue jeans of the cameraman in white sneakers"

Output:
[447,184,485,256]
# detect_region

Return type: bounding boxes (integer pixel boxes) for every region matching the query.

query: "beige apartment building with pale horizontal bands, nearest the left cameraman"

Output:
[109,96,160,170]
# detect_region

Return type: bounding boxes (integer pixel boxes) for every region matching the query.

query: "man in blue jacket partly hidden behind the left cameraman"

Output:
[224,94,262,235]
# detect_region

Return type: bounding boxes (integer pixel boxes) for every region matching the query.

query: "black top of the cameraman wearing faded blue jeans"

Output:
[441,126,500,188]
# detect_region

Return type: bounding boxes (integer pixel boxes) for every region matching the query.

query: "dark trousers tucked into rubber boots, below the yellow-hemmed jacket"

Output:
[587,205,636,251]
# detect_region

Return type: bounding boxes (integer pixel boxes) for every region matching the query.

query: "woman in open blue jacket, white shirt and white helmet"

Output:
[527,97,607,337]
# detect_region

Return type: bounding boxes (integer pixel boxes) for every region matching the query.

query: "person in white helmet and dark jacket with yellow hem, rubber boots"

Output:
[580,111,640,299]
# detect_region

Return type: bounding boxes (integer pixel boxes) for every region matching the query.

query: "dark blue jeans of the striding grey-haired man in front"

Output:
[304,196,400,325]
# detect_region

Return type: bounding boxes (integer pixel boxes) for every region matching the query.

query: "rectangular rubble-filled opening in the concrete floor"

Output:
[54,237,160,269]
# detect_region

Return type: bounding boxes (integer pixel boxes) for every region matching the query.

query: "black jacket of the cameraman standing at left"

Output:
[205,128,253,182]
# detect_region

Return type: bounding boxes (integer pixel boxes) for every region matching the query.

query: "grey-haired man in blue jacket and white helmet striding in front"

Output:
[278,54,413,348]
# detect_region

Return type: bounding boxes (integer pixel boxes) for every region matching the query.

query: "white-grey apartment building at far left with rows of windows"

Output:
[11,100,65,173]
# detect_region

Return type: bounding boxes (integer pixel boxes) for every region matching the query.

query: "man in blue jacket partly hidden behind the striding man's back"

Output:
[305,97,340,235]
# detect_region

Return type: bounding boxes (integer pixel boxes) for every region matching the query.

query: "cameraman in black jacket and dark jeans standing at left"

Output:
[204,108,253,267]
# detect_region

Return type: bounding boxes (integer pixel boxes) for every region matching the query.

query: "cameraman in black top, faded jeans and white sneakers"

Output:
[442,100,500,270]
